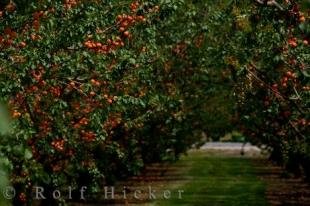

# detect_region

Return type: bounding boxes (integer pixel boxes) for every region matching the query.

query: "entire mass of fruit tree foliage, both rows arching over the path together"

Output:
[0,0,310,205]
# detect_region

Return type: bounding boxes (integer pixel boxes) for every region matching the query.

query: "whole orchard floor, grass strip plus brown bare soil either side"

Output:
[70,143,310,206]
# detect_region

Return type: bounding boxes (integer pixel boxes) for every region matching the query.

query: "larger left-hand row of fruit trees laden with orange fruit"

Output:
[0,0,226,205]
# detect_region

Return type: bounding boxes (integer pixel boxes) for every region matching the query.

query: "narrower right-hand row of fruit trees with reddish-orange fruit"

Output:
[227,1,310,177]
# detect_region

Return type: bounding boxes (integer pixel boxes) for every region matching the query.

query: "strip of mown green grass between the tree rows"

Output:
[152,152,268,206]
